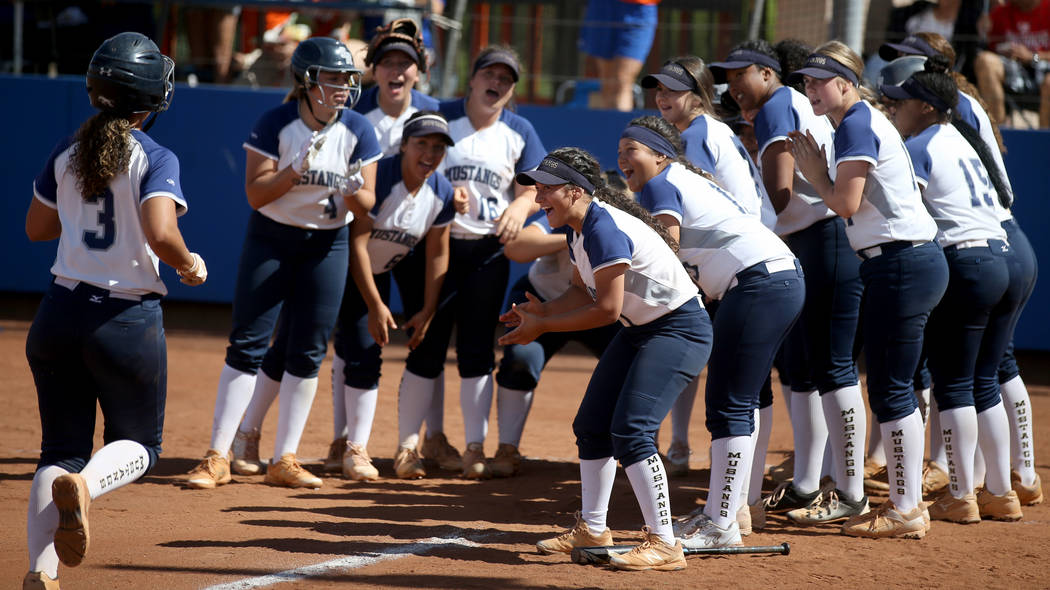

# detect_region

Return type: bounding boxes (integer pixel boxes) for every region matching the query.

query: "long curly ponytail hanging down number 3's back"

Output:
[69,111,133,198]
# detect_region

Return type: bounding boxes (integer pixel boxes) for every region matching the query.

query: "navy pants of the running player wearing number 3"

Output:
[25,282,168,472]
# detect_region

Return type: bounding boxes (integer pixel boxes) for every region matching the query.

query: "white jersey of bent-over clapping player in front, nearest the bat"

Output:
[557,198,702,325]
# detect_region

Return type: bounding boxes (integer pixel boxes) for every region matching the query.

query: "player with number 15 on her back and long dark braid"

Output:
[882,64,1021,523]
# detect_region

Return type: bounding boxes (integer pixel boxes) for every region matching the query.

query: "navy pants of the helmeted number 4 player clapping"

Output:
[226,211,350,378]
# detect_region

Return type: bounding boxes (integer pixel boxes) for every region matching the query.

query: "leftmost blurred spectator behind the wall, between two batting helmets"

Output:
[185,6,240,84]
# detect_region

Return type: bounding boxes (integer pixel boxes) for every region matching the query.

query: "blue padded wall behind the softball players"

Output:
[0,76,1050,351]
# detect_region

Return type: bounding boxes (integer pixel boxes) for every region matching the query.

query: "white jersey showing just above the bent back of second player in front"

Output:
[681,114,776,228]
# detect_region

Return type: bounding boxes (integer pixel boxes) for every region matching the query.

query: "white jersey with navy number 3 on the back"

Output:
[33,130,187,295]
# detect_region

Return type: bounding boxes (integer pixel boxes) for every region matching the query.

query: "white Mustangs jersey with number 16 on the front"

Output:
[440,99,547,237]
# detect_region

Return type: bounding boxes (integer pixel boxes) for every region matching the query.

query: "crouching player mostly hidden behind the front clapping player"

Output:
[488,208,621,478]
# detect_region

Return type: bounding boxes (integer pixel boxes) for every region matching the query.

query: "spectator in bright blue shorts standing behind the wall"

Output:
[580,0,659,111]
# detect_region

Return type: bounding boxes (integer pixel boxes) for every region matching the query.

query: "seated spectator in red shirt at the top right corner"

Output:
[974,0,1050,127]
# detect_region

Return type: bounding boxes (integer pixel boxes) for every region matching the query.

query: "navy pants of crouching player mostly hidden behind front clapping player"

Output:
[496,275,622,392]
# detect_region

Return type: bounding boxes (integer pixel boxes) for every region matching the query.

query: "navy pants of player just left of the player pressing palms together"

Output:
[784,216,864,394]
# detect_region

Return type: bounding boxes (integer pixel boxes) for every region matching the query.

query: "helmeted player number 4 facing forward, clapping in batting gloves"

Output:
[187,37,382,488]
